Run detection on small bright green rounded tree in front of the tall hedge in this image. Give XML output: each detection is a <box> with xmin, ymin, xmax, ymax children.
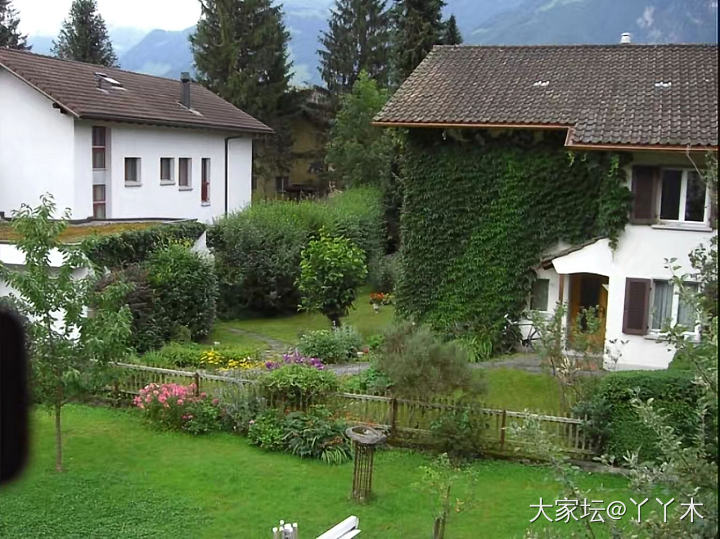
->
<box><xmin>297</xmin><ymin>232</ymin><xmax>367</xmax><ymax>327</ymax></box>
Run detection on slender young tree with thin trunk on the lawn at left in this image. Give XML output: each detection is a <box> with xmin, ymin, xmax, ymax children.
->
<box><xmin>0</xmin><ymin>195</ymin><xmax>131</xmax><ymax>471</ymax></box>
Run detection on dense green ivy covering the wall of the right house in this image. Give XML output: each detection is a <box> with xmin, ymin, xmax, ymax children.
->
<box><xmin>397</xmin><ymin>130</ymin><xmax>630</xmax><ymax>340</ymax></box>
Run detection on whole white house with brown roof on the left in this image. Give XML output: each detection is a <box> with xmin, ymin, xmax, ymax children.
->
<box><xmin>0</xmin><ymin>49</ymin><xmax>272</xmax><ymax>222</ymax></box>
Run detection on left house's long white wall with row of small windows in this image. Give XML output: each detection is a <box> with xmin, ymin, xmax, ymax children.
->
<box><xmin>105</xmin><ymin>123</ymin><xmax>252</xmax><ymax>223</ymax></box>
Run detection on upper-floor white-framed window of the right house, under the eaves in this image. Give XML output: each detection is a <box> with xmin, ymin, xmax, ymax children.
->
<box><xmin>659</xmin><ymin>169</ymin><xmax>707</xmax><ymax>223</ymax></box>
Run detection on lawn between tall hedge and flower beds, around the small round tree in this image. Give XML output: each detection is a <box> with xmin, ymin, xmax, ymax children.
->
<box><xmin>217</xmin><ymin>286</ymin><xmax>395</xmax><ymax>344</ymax></box>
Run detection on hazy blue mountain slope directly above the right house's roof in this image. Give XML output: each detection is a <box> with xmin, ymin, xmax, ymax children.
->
<box><xmin>465</xmin><ymin>0</ymin><xmax>718</xmax><ymax>45</ymax></box>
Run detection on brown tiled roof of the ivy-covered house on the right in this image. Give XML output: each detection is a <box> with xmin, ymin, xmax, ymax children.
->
<box><xmin>375</xmin><ymin>45</ymin><xmax>718</xmax><ymax>147</ymax></box>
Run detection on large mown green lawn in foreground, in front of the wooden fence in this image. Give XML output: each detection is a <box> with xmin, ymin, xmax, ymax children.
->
<box><xmin>0</xmin><ymin>405</ymin><xmax>629</xmax><ymax>539</ymax></box>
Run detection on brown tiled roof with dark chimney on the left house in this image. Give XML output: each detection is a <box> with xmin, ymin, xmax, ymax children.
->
<box><xmin>0</xmin><ymin>48</ymin><xmax>272</xmax><ymax>133</ymax></box>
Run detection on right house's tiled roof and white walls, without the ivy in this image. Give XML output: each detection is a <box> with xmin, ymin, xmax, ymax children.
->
<box><xmin>374</xmin><ymin>44</ymin><xmax>718</xmax><ymax>369</ymax></box>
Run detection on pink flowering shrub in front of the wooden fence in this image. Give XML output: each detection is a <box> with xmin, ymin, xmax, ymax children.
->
<box><xmin>133</xmin><ymin>383</ymin><xmax>220</xmax><ymax>434</ymax></box>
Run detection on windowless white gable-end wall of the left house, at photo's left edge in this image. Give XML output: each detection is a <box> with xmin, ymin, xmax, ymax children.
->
<box><xmin>0</xmin><ymin>68</ymin><xmax>76</xmax><ymax>218</ymax></box>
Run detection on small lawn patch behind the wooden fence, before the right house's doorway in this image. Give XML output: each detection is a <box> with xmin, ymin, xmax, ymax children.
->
<box><xmin>483</xmin><ymin>369</ymin><xmax>565</xmax><ymax>414</ymax></box>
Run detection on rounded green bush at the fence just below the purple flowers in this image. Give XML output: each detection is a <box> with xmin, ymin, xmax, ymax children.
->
<box><xmin>258</xmin><ymin>365</ymin><xmax>338</xmax><ymax>410</ymax></box>
